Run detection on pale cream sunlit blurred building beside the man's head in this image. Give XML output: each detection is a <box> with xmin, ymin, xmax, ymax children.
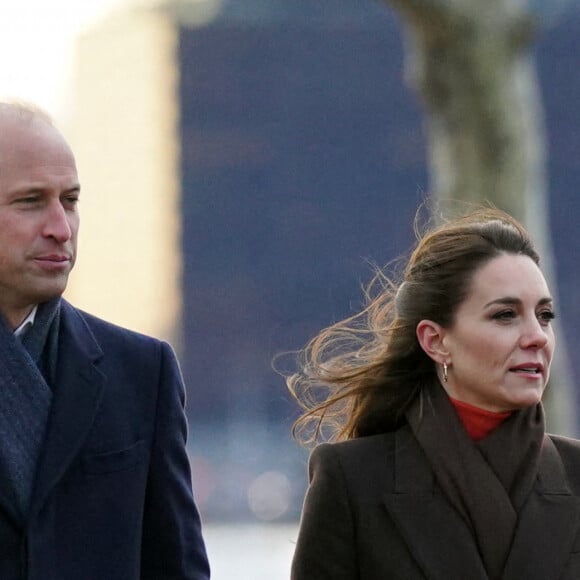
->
<box><xmin>67</xmin><ymin>0</ymin><xmax>181</xmax><ymax>343</ymax></box>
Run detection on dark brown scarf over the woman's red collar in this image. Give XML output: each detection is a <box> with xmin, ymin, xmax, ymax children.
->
<box><xmin>407</xmin><ymin>385</ymin><xmax>544</xmax><ymax>580</ymax></box>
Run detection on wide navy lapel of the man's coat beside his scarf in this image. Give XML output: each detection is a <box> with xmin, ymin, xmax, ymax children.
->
<box><xmin>31</xmin><ymin>301</ymin><xmax>105</xmax><ymax>515</ymax></box>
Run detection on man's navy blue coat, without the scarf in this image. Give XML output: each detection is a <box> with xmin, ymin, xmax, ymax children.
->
<box><xmin>0</xmin><ymin>301</ymin><xmax>209</xmax><ymax>580</ymax></box>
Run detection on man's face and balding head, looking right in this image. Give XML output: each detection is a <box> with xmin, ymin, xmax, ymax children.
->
<box><xmin>0</xmin><ymin>116</ymin><xmax>79</xmax><ymax>326</ymax></box>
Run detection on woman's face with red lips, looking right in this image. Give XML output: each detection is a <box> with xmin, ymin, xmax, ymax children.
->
<box><xmin>442</xmin><ymin>254</ymin><xmax>555</xmax><ymax>411</ymax></box>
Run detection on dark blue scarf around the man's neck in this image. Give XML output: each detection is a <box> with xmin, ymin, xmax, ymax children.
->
<box><xmin>0</xmin><ymin>298</ymin><xmax>60</xmax><ymax>518</ymax></box>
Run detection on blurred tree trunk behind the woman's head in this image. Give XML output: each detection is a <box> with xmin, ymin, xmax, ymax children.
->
<box><xmin>385</xmin><ymin>0</ymin><xmax>576</xmax><ymax>435</ymax></box>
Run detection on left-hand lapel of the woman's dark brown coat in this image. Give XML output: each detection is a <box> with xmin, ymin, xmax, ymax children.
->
<box><xmin>384</xmin><ymin>429</ymin><xmax>490</xmax><ymax>580</ymax></box>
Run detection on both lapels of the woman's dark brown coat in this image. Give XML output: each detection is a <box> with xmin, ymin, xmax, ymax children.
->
<box><xmin>384</xmin><ymin>428</ymin><xmax>580</xmax><ymax>580</ymax></box>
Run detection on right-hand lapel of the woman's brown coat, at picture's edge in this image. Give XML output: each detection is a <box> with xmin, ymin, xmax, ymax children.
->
<box><xmin>504</xmin><ymin>436</ymin><xmax>580</xmax><ymax>580</ymax></box>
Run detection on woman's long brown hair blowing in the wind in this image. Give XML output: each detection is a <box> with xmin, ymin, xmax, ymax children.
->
<box><xmin>287</xmin><ymin>208</ymin><xmax>539</xmax><ymax>444</ymax></box>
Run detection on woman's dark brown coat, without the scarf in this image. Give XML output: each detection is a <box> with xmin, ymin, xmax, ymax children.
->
<box><xmin>292</xmin><ymin>427</ymin><xmax>580</xmax><ymax>580</ymax></box>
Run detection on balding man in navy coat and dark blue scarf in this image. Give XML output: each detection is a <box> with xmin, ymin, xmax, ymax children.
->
<box><xmin>0</xmin><ymin>103</ymin><xmax>209</xmax><ymax>580</ymax></box>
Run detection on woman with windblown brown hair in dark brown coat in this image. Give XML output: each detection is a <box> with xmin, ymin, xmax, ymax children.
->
<box><xmin>288</xmin><ymin>210</ymin><xmax>580</xmax><ymax>580</ymax></box>
